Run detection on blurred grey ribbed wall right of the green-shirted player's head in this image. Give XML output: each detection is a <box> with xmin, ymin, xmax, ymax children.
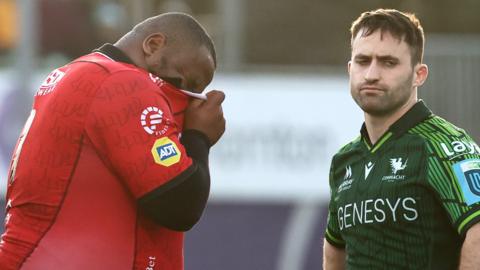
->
<box><xmin>420</xmin><ymin>34</ymin><xmax>480</xmax><ymax>143</ymax></box>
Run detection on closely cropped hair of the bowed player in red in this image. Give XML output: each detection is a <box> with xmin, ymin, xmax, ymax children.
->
<box><xmin>133</xmin><ymin>12</ymin><xmax>217</xmax><ymax>66</ymax></box>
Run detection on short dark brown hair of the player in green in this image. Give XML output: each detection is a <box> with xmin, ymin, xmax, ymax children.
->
<box><xmin>350</xmin><ymin>9</ymin><xmax>425</xmax><ymax>65</ymax></box>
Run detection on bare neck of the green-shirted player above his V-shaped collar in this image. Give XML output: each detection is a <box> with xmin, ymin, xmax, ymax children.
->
<box><xmin>364</xmin><ymin>99</ymin><xmax>417</xmax><ymax>145</ymax></box>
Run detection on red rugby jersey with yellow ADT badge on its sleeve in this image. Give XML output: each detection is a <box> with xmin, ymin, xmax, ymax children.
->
<box><xmin>0</xmin><ymin>49</ymin><xmax>197</xmax><ymax>270</ymax></box>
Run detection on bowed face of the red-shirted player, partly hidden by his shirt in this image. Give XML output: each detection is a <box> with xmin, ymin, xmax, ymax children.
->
<box><xmin>148</xmin><ymin>47</ymin><xmax>215</xmax><ymax>93</ymax></box>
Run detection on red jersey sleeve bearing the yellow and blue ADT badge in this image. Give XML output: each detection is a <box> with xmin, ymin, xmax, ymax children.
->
<box><xmin>86</xmin><ymin>71</ymin><xmax>192</xmax><ymax>199</ymax></box>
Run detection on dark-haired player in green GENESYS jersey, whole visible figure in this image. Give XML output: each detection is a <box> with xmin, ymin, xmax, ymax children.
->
<box><xmin>324</xmin><ymin>9</ymin><xmax>480</xmax><ymax>270</ymax></box>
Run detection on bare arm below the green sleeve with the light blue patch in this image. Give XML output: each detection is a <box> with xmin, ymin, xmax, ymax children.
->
<box><xmin>459</xmin><ymin>223</ymin><xmax>480</xmax><ymax>270</ymax></box>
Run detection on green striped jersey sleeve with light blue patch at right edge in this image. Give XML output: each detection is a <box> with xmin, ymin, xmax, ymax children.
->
<box><xmin>427</xmin><ymin>134</ymin><xmax>480</xmax><ymax>236</ymax></box>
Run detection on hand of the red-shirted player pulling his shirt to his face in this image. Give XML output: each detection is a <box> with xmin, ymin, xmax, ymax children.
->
<box><xmin>183</xmin><ymin>90</ymin><xmax>225</xmax><ymax>145</ymax></box>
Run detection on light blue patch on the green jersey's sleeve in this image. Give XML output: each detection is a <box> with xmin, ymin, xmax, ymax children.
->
<box><xmin>453</xmin><ymin>159</ymin><xmax>480</xmax><ymax>205</ymax></box>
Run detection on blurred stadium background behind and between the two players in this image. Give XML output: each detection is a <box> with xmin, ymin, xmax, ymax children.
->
<box><xmin>0</xmin><ymin>0</ymin><xmax>480</xmax><ymax>270</ymax></box>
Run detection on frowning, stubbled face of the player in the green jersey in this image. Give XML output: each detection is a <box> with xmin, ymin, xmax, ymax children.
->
<box><xmin>348</xmin><ymin>31</ymin><xmax>417</xmax><ymax>116</ymax></box>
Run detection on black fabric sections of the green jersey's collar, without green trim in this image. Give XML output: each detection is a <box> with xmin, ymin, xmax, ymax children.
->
<box><xmin>360</xmin><ymin>100</ymin><xmax>432</xmax><ymax>142</ymax></box>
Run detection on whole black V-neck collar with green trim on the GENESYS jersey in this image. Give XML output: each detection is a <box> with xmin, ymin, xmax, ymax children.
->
<box><xmin>360</xmin><ymin>100</ymin><xmax>432</xmax><ymax>153</ymax></box>
